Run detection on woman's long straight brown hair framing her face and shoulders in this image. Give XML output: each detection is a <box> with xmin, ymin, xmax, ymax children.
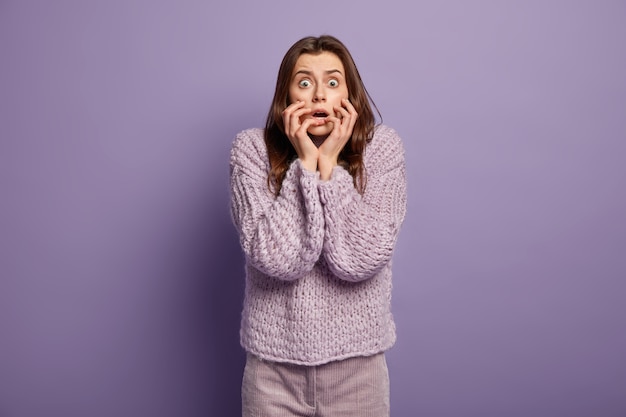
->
<box><xmin>265</xmin><ymin>35</ymin><xmax>380</xmax><ymax>195</ymax></box>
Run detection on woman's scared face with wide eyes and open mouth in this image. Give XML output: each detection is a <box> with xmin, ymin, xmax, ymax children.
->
<box><xmin>289</xmin><ymin>52</ymin><xmax>348</xmax><ymax>137</ymax></box>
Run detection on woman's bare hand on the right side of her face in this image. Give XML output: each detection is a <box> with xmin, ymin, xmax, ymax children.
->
<box><xmin>317</xmin><ymin>99</ymin><xmax>359</xmax><ymax>180</ymax></box>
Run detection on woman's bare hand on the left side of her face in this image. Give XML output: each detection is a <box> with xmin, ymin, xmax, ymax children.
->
<box><xmin>283</xmin><ymin>101</ymin><xmax>319</xmax><ymax>172</ymax></box>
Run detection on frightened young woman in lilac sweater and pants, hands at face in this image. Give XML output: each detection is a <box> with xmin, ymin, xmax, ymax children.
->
<box><xmin>230</xmin><ymin>36</ymin><xmax>406</xmax><ymax>417</ymax></box>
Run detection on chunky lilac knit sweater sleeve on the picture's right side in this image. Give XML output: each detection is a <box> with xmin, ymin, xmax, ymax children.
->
<box><xmin>319</xmin><ymin>126</ymin><xmax>406</xmax><ymax>281</ymax></box>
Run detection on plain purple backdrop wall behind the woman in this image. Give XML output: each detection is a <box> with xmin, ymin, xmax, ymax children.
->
<box><xmin>0</xmin><ymin>0</ymin><xmax>626</xmax><ymax>417</ymax></box>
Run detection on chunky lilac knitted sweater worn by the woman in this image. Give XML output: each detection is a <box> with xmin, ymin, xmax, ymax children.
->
<box><xmin>230</xmin><ymin>125</ymin><xmax>406</xmax><ymax>365</ymax></box>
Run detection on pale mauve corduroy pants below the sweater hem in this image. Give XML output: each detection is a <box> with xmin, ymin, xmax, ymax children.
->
<box><xmin>241</xmin><ymin>353</ymin><xmax>389</xmax><ymax>417</ymax></box>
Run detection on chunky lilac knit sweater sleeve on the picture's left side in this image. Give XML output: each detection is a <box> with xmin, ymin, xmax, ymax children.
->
<box><xmin>230</xmin><ymin>129</ymin><xmax>324</xmax><ymax>280</ymax></box>
